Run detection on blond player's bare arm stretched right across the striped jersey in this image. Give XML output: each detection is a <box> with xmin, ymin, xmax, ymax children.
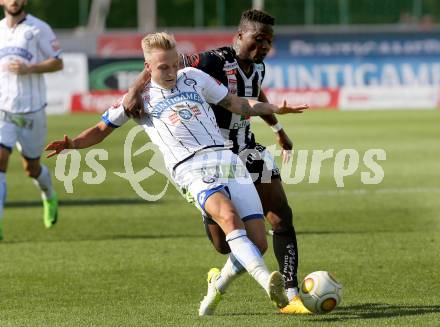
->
<box><xmin>218</xmin><ymin>93</ymin><xmax>309</xmax><ymax>116</ymax></box>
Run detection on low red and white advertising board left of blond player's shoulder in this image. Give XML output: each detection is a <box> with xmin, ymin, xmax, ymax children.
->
<box><xmin>70</xmin><ymin>90</ymin><xmax>125</xmax><ymax>113</ymax></box>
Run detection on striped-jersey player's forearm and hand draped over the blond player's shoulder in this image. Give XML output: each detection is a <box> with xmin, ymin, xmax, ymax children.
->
<box><xmin>122</xmin><ymin>69</ymin><xmax>150</xmax><ymax>118</ymax></box>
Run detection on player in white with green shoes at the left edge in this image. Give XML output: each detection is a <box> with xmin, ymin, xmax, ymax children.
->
<box><xmin>0</xmin><ymin>0</ymin><xmax>63</xmax><ymax>239</ymax></box>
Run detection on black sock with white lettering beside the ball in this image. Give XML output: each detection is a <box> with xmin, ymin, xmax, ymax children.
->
<box><xmin>273</xmin><ymin>226</ymin><xmax>298</xmax><ymax>288</ymax></box>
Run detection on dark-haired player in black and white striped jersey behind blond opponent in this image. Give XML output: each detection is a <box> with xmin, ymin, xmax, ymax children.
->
<box><xmin>124</xmin><ymin>10</ymin><xmax>309</xmax><ymax>314</ymax></box>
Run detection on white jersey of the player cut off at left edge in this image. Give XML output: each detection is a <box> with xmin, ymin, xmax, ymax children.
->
<box><xmin>0</xmin><ymin>14</ymin><xmax>61</xmax><ymax>113</ymax></box>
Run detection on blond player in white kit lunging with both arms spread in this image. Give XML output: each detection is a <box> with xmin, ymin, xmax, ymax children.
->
<box><xmin>46</xmin><ymin>33</ymin><xmax>306</xmax><ymax>315</ymax></box>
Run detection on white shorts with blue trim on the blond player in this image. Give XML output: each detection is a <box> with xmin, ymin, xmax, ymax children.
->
<box><xmin>173</xmin><ymin>149</ymin><xmax>264</xmax><ymax>221</ymax></box>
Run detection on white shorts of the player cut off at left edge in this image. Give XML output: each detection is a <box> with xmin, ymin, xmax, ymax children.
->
<box><xmin>0</xmin><ymin>109</ymin><xmax>47</xmax><ymax>159</ymax></box>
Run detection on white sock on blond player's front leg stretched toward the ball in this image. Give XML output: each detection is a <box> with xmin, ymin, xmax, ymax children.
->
<box><xmin>226</xmin><ymin>229</ymin><xmax>270</xmax><ymax>292</ymax></box>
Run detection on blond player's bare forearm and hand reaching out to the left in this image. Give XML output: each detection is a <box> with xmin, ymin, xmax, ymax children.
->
<box><xmin>45</xmin><ymin>121</ymin><xmax>115</xmax><ymax>158</ymax></box>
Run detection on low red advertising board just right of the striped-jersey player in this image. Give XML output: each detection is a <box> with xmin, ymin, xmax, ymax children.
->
<box><xmin>264</xmin><ymin>88</ymin><xmax>339</xmax><ymax>109</ymax></box>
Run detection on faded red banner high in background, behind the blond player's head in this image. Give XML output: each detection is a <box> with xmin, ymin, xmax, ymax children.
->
<box><xmin>97</xmin><ymin>32</ymin><xmax>234</xmax><ymax>57</ymax></box>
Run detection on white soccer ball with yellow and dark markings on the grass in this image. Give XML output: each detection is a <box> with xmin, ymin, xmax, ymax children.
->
<box><xmin>299</xmin><ymin>271</ymin><xmax>342</xmax><ymax>313</ymax></box>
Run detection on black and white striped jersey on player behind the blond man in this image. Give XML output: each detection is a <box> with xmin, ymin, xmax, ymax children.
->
<box><xmin>182</xmin><ymin>47</ymin><xmax>265</xmax><ymax>153</ymax></box>
